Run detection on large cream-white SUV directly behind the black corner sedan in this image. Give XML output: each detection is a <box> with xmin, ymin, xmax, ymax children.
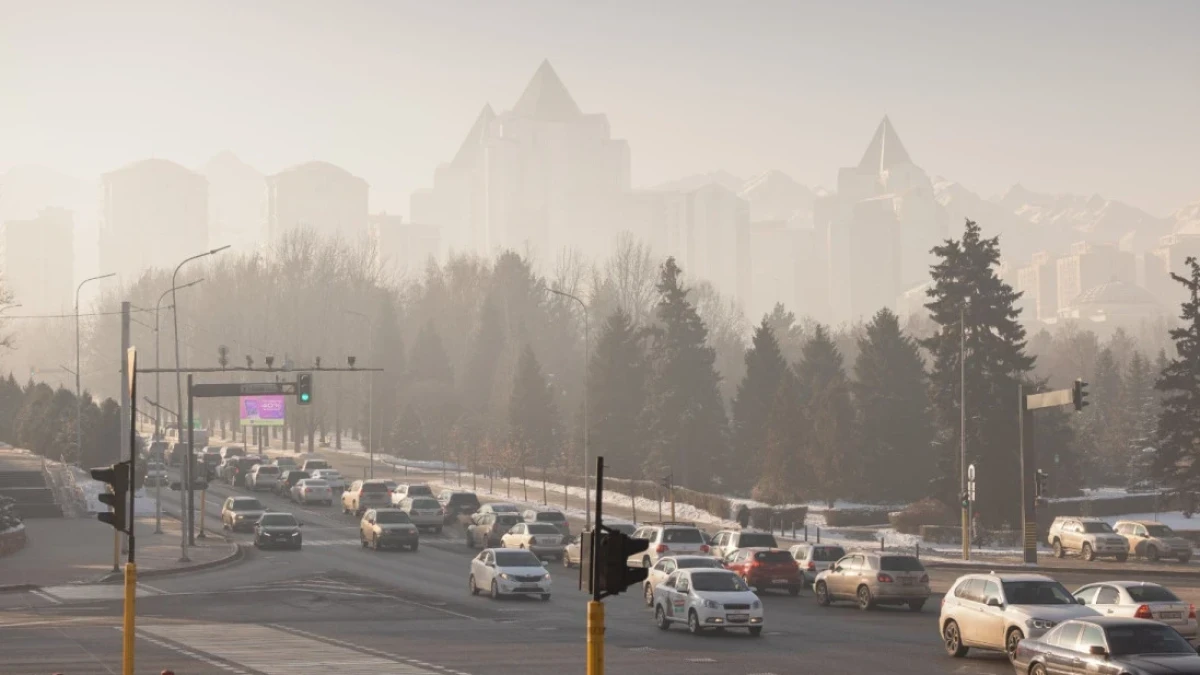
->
<box><xmin>940</xmin><ymin>573</ymin><xmax>1098</xmax><ymax>661</ymax></box>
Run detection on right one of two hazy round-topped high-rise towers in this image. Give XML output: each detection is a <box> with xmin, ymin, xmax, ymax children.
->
<box><xmin>266</xmin><ymin>162</ymin><xmax>370</xmax><ymax>244</ymax></box>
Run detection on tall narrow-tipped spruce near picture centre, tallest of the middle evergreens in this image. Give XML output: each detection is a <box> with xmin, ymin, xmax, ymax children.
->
<box><xmin>643</xmin><ymin>257</ymin><xmax>728</xmax><ymax>490</ymax></box>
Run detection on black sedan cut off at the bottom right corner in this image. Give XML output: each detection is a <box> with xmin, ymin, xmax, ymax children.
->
<box><xmin>1013</xmin><ymin>616</ymin><xmax>1200</xmax><ymax>675</ymax></box>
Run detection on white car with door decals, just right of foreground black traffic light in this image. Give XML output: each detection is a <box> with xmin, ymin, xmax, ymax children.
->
<box><xmin>654</xmin><ymin>569</ymin><xmax>763</xmax><ymax>637</ymax></box>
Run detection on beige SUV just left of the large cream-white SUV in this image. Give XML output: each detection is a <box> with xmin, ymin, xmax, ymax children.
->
<box><xmin>812</xmin><ymin>552</ymin><xmax>930</xmax><ymax>611</ymax></box>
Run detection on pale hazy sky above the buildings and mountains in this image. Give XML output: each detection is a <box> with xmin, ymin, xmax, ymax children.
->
<box><xmin>0</xmin><ymin>0</ymin><xmax>1200</xmax><ymax>214</ymax></box>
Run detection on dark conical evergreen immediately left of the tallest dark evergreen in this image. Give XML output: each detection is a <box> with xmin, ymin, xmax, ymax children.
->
<box><xmin>853</xmin><ymin>309</ymin><xmax>936</xmax><ymax>503</ymax></box>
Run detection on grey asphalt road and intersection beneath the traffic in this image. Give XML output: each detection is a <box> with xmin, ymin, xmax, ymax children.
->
<box><xmin>7</xmin><ymin>461</ymin><xmax>1200</xmax><ymax>675</ymax></box>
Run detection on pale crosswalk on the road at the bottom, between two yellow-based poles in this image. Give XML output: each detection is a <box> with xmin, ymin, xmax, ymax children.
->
<box><xmin>138</xmin><ymin>623</ymin><xmax>455</xmax><ymax>675</ymax></box>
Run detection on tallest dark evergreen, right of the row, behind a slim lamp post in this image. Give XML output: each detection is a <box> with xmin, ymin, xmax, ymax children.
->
<box><xmin>922</xmin><ymin>220</ymin><xmax>1034</xmax><ymax>525</ymax></box>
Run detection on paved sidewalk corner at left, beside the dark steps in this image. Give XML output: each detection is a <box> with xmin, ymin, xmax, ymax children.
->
<box><xmin>0</xmin><ymin>515</ymin><xmax>240</xmax><ymax>590</ymax></box>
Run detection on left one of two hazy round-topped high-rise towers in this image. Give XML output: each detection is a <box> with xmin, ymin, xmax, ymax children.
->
<box><xmin>100</xmin><ymin>160</ymin><xmax>209</xmax><ymax>281</ymax></box>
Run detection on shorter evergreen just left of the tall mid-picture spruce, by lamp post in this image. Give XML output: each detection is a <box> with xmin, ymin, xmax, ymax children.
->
<box><xmin>588</xmin><ymin>307</ymin><xmax>646</xmax><ymax>478</ymax></box>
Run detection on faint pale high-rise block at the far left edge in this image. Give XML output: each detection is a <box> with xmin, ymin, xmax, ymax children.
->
<box><xmin>4</xmin><ymin>209</ymin><xmax>74</xmax><ymax>313</ymax></box>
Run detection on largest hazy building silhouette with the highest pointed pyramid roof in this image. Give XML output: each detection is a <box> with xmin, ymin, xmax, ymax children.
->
<box><xmin>410</xmin><ymin>61</ymin><xmax>630</xmax><ymax>259</ymax></box>
